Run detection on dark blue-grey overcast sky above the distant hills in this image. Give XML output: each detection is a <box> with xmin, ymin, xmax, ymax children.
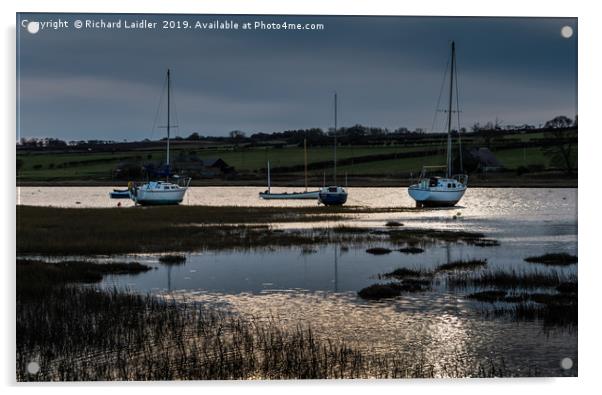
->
<box><xmin>17</xmin><ymin>14</ymin><xmax>577</xmax><ymax>141</ymax></box>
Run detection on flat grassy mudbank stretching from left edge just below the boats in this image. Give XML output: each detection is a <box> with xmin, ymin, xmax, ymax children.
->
<box><xmin>17</xmin><ymin>206</ymin><xmax>492</xmax><ymax>255</ymax></box>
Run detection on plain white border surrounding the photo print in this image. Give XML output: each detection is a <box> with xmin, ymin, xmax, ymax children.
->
<box><xmin>0</xmin><ymin>0</ymin><xmax>602</xmax><ymax>395</ymax></box>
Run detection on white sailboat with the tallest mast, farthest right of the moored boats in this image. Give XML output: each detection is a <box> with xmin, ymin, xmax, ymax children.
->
<box><xmin>408</xmin><ymin>41</ymin><xmax>468</xmax><ymax>207</ymax></box>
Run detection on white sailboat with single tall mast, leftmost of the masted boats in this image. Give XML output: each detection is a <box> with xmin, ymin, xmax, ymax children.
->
<box><xmin>128</xmin><ymin>69</ymin><xmax>191</xmax><ymax>205</ymax></box>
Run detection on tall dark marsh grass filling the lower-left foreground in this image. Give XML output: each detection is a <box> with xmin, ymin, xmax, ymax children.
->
<box><xmin>16</xmin><ymin>261</ymin><xmax>502</xmax><ymax>381</ymax></box>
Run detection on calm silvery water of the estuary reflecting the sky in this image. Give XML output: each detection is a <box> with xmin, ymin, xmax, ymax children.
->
<box><xmin>18</xmin><ymin>187</ymin><xmax>577</xmax><ymax>376</ymax></box>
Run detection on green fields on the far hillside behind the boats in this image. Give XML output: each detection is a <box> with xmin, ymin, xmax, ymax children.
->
<box><xmin>17</xmin><ymin>132</ymin><xmax>577</xmax><ymax>182</ymax></box>
